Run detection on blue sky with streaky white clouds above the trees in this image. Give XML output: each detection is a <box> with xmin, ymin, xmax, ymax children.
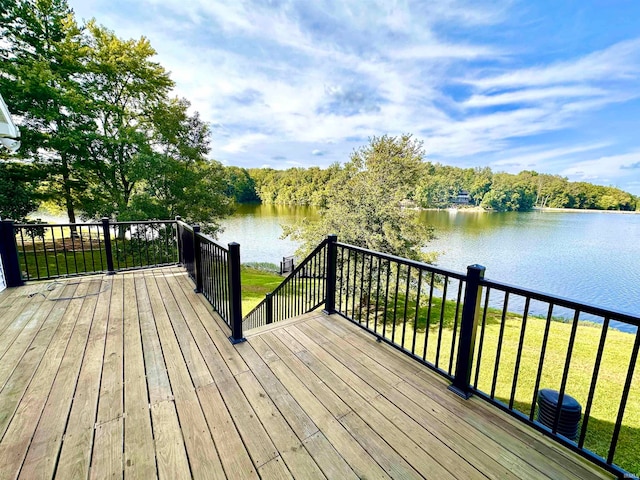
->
<box><xmin>69</xmin><ymin>0</ymin><xmax>640</xmax><ymax>195</ymax></box>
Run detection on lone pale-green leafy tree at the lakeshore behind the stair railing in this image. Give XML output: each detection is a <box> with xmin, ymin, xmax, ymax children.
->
<box><xmin>285</xmin><ymin>135</ymin><xmax>433</xmax><ymax>259</ymax></box>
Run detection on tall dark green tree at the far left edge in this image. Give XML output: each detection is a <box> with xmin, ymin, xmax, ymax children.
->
<box><xmin>0</xmin><ymin>0</ymin><xmax>95</xmax><ymax>229</ymax></box>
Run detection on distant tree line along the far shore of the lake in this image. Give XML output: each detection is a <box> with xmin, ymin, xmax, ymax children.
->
<box><xmin>242</xmin><ymin>162</ymin><xmax>640</xmax><ymax>212</ymax></box>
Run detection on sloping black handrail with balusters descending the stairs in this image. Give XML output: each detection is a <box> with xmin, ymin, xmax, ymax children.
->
<box><xmin>243</xmin><ymin>237</ymin><xmax>335</xmax><ymax>330</ymax></box>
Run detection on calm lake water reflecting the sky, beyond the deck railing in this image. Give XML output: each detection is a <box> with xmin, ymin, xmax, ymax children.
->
<box><xmin>220</xmin><ymin>205</ymin><xmax>640</xmax><ymax>324</ymax></box>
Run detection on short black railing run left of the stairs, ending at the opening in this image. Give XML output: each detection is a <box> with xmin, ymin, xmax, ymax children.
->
<box><xmin>176</xmin><ymin>217</ymin><xmax>244</xmax><ymax>343</ymax></box>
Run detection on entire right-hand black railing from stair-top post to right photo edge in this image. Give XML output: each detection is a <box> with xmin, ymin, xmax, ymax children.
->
<box><xmin>327</xmin><ymin>238</ymin><xmax>640</xmax><ymax>476</ymax></box>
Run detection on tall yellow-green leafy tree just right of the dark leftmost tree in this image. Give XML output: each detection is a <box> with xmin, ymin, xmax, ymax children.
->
<box><xmin>82</xmin><ymin>22</ymin><xmax>173</xmax><ymax>218</ymax></box>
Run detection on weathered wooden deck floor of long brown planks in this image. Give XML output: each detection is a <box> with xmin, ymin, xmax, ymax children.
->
<box><xmin>0</xmin><ymin>268</ymin><xmax>608</xmax><ymax>480</ymax></box>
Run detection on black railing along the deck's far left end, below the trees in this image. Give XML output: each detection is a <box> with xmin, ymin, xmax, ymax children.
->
<box><xmin>2</xmin><ymin>218</ymin><xmax>178</xmax><ymax>282</ymax></box>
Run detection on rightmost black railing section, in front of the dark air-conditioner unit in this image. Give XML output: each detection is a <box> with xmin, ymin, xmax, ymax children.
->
<box><xmin>471</xmin><ymin>279</ymin><xmax>640</xmax><ymax>475</ymax></box>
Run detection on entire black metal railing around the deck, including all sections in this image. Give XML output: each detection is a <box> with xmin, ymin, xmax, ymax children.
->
<box><xmin>0</xmin><ymin>219</ymin><xmax>640</xmax><ymax>476</ymax></box>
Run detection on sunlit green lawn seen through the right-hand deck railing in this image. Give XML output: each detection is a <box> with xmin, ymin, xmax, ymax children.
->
<box><xmin>355</xmin><ymin>298</ymin><xmax>640</xmax><ymax>475</ymax></box>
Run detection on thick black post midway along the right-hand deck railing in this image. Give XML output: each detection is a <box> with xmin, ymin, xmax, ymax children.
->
<box><xmin>449</xmin><ymin>265</ymin><xmax>485</xmax><ymax>399</ymax></box>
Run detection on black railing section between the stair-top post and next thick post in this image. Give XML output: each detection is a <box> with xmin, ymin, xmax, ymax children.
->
<box><xmin>335</xmin><ymin>243</ymin><xmax>465</xmax><ymax>379</ymax></box>
